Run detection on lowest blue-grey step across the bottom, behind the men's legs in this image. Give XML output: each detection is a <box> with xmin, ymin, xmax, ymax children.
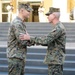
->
<box><xmin>0</xmin><ymin>65</ymin><xmax>75</xmax><ymax>75</ymax></box>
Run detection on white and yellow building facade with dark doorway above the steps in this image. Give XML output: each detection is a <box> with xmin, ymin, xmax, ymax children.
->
<box><xmin>0</xmin><ymin>0</ymin><xmax>75</xmax><ymax>22</ymax></box>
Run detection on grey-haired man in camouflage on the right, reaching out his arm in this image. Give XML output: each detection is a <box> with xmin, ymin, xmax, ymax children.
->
<box><xmin>20</xmin><ymin>7</ymin><xmax>66</xmax><ymax>75</ymax></box>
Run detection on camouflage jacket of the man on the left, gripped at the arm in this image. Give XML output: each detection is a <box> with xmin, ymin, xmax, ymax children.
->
<box><xmin>7</xmin><ymin>17</ymin><xmax>33</xmax><ymax>59</ymax></box>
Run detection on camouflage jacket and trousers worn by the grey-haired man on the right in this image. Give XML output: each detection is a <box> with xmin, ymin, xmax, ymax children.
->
<box><xmin>35</xmin><ymin>22</ymin><xmax>66</xmax><ymax>75</ymax></box>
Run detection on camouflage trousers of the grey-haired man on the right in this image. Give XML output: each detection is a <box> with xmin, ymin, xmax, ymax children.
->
<box><xmin>48</xmin><ymin>64</ymin><xmax>63</xmax><ymax>75</ymax></box>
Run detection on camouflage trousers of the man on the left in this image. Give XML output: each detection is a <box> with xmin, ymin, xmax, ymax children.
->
<box><xmin>8</xmin><ymin>58</ymin><xmax>25</xmax><ymax>75</ymax></box>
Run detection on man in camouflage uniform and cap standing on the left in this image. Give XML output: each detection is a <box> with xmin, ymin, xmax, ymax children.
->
<box><xmin>7</xmin><ymin>3</ymin><xmax>33</xmax><ymax>75</ymax></box>
